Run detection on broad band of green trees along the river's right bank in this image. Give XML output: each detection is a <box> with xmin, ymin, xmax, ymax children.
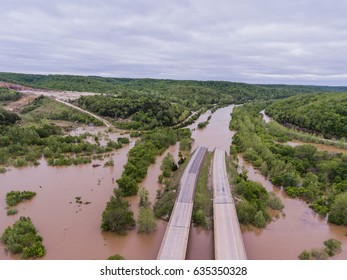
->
<box><xmin>231</xmin><ymin>102</ymin><xmax>347</xmax><ymax>225</ymax></box>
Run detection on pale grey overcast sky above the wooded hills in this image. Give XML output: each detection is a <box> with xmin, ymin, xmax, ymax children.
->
<box><xmin>0</xmin><ymin>0</ymin><xmax>347</xmax><ymax>85</ymax></box>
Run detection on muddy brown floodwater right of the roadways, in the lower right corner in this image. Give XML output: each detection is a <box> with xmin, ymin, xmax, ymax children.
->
<box><xmin>239</xmin><ymin>157</ymin><xmax>347</xmax><ymax>260</ymax></box>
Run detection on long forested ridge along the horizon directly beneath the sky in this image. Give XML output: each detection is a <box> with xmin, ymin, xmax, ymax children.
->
<box><xmin>0</xmin><ymin>73</ymin><xmax>312</xmax><ymax>104</ymax></box>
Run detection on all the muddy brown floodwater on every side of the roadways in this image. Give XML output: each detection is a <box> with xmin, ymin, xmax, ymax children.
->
<box><xmin>0</xmin><ymin>106</ymin><xmax>347</xmax><ymax>260</ymax></box>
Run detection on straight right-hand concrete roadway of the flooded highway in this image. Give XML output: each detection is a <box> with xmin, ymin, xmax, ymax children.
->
<box><xmin>213</xmin><ymin>149</ymin><xmax>247</xmax><ymax>260</ymax></box>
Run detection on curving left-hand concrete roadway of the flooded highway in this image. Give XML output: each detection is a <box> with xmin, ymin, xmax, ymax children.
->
<box><xmin>157</xmin><ymin>147</ymin><xmax>207</xmax><ymax>260</ymax></box>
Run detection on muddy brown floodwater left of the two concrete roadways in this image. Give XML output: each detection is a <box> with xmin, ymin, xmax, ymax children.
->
<box><xmin>0</xmin><ymin>128</ymin><xmax>178</xmax><ymax>260</ymax></box>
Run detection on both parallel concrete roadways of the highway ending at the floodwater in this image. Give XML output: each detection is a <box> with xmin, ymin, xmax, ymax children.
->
<box><xmin>157</xmin><ymin>147</ymin><xmax>247</xmax><ymax>260</ymax></box>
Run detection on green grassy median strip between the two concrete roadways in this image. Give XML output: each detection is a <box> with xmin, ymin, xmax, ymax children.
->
<box><xmin>193</xmin><ymin>152</ymin><xmax>213</xmax><ymax>229</ymax></box>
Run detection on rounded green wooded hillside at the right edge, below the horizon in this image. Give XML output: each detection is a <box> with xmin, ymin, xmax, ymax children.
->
<box><xmin>266</xmin><ymin>93</ymin><xmax>347</xmax><ymax>138</ymax></box>
